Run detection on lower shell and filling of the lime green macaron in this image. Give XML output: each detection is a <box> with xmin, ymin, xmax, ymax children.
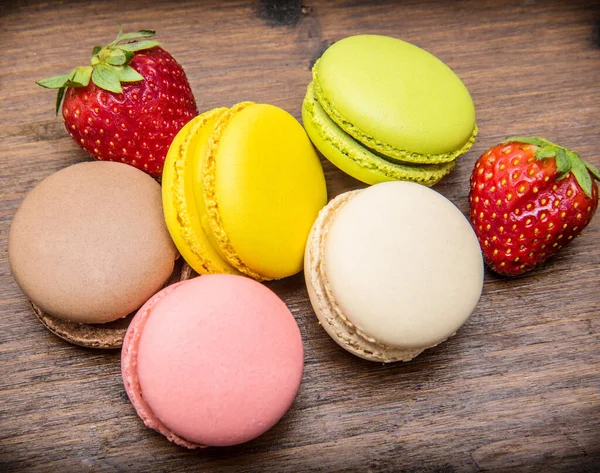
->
<box><xmin>302</xmin><ymin>82</ymin><xmax>456</xmax><ymax>186</ymax></box>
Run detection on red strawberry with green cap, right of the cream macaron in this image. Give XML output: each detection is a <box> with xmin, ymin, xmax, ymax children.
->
<box><xmin>469</xmin><ymin>137</ymin><xmax>600</xmax><ymax>276</ymax></box>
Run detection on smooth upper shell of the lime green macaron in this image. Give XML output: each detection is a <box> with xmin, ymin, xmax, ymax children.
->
<box><xmin>313</xmin><ymin>35</ymin><xmax>475</xmax><ymax>159</ymax></box>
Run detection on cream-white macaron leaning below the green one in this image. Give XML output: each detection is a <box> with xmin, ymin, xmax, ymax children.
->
<box><xmin>305</xmin><ymin>181</ymin><xmax>483</xmax><ymax>362</ymax></box>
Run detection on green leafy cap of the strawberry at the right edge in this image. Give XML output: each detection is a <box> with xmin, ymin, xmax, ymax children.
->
<box><xmin>502</xmin><ymin>136</ymin><xmax>600</xmax><ymax>197</ymax></box>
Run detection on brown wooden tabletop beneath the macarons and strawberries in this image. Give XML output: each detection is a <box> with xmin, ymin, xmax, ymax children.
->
<box><xmin>0</xmin><ymin>0</ymin><xmax>600</xmax><ymax>472</ymax></box>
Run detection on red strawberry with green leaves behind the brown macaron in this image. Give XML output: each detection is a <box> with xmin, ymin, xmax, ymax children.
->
<box><xmin>37</xmin><ymin>30</ymin><xmax>198</xmax><ymax>177</ymax></box>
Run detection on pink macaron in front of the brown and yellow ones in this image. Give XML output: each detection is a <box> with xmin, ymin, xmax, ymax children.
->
<box><xmin>121</xmin><ymin>274</ymin><xmax>304</xmax><ymax>448</ymax></box>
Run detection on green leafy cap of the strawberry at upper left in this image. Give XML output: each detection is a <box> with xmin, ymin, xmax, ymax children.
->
<box><xmin>36</xmin><ymin>26</ymin><xmax>159</xmax><ymax>115</ymax></box>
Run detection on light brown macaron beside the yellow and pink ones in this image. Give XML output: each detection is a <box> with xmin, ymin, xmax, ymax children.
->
<box><xmin>8</xmin><ymin>162</ymin><xmax>178</xmax><ymax>348</ymax></box>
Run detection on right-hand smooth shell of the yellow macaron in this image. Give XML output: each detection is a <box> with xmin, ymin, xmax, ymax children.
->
<box><xmin>204</xmin><ymin>102</ymin><xmax>327</xmax><ymax>279</ymax></box>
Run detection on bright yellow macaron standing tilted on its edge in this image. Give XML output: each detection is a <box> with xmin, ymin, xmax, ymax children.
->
<box><xmin>162</xmin><ymin>102</ymin><xmax>327</xmax><ymax>281</ymax></box>
